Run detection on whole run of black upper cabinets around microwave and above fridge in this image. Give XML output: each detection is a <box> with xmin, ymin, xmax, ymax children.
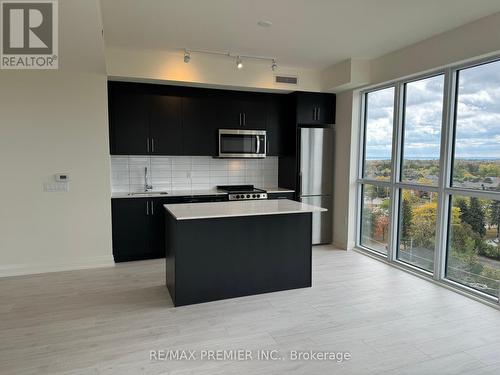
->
<box><xmin>108</xmin><ymin>82</ymin><xmax>335</xmax><ymax>156</ymax></box>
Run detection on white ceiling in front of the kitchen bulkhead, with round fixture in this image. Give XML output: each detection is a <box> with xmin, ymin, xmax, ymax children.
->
<box><xmin>101</xmin><ymin>0</ymin><xmax>500</xmax><ymax>69</ymax></box>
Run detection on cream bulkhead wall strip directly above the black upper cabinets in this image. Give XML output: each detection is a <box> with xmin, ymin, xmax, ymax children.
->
<box><xmin>106</xmin><ymin>47</ymin><xmax>321</xmax><ymax>91</ymax></box>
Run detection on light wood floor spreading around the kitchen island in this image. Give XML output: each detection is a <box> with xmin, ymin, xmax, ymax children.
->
<box><xmin>0</xmin><ymin>247</ymin><xmax>500</xmax><ymax>375</ymax></box>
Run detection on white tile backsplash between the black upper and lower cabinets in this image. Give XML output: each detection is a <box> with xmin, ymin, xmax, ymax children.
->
<box><xmin>111</xmin><ymin>156</ymin><xmax>278</xmax><ymax>192</ymax></box>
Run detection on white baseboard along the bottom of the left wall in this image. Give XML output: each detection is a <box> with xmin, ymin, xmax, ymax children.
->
<box><xmin>0</xmin><ymin>255</ymin><xmax>115</xmax><ymax>277</ymax></box>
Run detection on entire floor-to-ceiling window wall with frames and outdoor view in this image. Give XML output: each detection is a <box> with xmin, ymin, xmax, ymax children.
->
<box><xmin>357</xmin><ymin>61</ymin><xmax>500</xmax><ymax>306</ymax></box>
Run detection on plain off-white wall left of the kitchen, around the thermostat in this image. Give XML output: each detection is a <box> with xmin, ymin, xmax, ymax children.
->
<box><xmin>0</xmin><ymin>71</ymin><xmax>113</xmax><ymax>276</ymax></box>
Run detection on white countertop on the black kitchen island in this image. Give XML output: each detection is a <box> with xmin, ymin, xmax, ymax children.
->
<box><xmin>164</xmin><ymin>199</ymin><xmax>327</xmax><ymax>220</ymax></box>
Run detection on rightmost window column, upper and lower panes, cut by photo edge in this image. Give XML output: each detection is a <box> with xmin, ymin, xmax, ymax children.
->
<box><xmin>446</xmin><ymin>61</ymin><xmax>500</xmax><ymax>297</ymax></box>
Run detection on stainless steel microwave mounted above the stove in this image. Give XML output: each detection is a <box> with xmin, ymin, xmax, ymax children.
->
<box><xmin>219</xmin><ymin>129</ymin><xmax>267</xmax><ymax>158</ymax></box>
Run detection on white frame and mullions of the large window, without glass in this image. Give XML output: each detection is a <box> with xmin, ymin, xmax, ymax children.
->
<box><xmin>355</xmin><ymin>56</ymin><xmax>500</xmax><ymax>307</ymax></box>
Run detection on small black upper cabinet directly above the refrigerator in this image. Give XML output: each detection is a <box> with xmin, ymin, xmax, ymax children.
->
<box><xmin>294</xmin><ymin>92</ymin><xmax>335</xmax><ymax>125</ymax></box>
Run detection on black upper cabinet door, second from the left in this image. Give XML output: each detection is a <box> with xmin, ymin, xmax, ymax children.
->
<box><xmin>150</xmin><ymin>95</ymin><xmax>186</xmax><ymax>155</ymax></box>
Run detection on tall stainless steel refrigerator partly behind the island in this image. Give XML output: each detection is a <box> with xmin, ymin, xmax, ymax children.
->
<box><xmin>299</xmin><ymin>128</ymin><xmax>335</xmax><ymax>245</ymax></box>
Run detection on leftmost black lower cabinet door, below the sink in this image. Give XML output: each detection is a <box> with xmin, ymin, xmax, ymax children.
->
<box><xmin>111</xmin><ymin>198</ymin><xmax>151</xmax><ymax>262</ymax></box>
